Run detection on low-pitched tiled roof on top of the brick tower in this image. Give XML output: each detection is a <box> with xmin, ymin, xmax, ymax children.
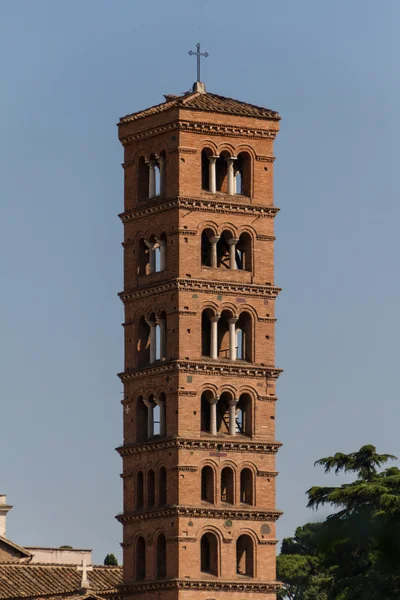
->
<box><xmin>120</xmin><ymin>92</ymin><xmax>280</xmax><ymax>124</ymax></box>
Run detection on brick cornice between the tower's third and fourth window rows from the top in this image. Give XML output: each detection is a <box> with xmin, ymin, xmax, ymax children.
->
<box><xmin>118</xmin><ymin>359</ymin><xmax>283</xmax><ymax>383</ymax></box>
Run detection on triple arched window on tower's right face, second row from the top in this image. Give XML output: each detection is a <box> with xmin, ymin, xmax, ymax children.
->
<box><xmin>201</xmin><ymin>228</ymin><xmax>253</xmax><ymax>271</ymax></box>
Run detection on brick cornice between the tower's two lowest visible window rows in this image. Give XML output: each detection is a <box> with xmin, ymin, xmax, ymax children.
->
<box><xmin>116</xmin><ymin>506</ymin><xmax>283</xmax><ymax>523</ymax></box>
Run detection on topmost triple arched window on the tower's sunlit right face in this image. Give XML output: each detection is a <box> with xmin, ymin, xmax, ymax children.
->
<box><xmin>201</xmin><ymin>148</ymin><xmax>252</xmax><ymax>197</ymax></box>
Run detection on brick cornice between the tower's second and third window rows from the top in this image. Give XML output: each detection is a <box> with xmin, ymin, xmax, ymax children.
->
<box><xmin>118</xmin><ymin>277</ymin><xmax>281</xmax><ymax>304</ymax></box>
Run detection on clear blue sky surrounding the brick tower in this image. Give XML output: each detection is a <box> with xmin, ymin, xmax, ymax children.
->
<box><xmin>0</xmin><ymin>0</ymin><xmax>400</xmax><ymax>562</ymax></box>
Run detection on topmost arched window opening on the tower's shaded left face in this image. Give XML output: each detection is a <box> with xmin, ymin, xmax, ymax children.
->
<box><xmin>137</xmin><ymin>151</ymin><xmax>166</xmax><ymax>201</ymax></box>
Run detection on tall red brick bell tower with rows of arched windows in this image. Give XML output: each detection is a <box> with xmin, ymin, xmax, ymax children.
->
<box><xmin>118</xmin><ymin>83</ymin><xmax>280</xmax><ymax>600</ymax></box>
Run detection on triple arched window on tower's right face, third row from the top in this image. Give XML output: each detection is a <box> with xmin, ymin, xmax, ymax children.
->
<box><xmin>201</xmin><ymin>308</ymin><xmax>253</xmax><ymax>362</ymax></box>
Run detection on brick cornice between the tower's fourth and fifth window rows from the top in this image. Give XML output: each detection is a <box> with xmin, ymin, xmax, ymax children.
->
<box><xmin>116</xmin><ymin>438</ymin><xmax>282</xmax><ymax>457</ymax></box>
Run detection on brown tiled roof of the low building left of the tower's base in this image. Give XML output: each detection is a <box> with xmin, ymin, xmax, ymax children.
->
<box><xmin>0</xmin><ymin>563</ymin><xmax>122</xmax><ymax>599</ymax></box>
